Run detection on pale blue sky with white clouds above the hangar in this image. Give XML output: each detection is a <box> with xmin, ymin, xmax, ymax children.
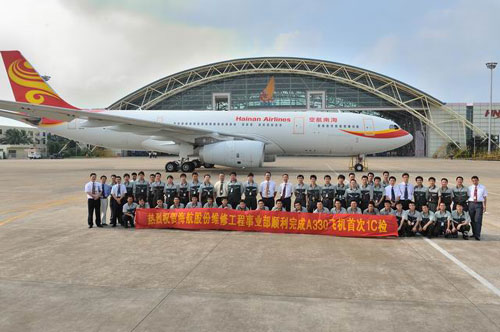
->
<box><xmin>0</xmin><ymin>0</ymin><xmax>500</xmax><ymax>124</ymax></box>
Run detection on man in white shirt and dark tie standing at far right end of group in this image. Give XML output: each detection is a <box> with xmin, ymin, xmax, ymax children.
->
<box><xmin>468</xmin><ymin>175</ymin><xmax>488</xmax><ymax>241</ymax></box>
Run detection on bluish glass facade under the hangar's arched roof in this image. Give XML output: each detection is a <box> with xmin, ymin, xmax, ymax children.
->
<box><xmin>150</xmin><ymin>73</ymin><xmax>396</xmax><ymax>110</ymax></box>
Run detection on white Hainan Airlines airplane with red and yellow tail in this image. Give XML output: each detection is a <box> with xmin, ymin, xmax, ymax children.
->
<box><xmin>0</xmin><ymin>51</ymin><xmax>413</xmax><ymax>172</ymax></box>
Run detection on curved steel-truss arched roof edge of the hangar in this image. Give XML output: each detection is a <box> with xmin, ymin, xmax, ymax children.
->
<box><xmin>108</xmin><ymin>57</ymin><xmax>443</xmax><ymax>109</ymax></box>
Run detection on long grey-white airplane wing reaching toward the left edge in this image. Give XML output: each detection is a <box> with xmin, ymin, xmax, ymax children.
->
<box><xmin>0</xmin><ymin>100</ymin><xmax>267</xmax><ymax>144</ymax></box>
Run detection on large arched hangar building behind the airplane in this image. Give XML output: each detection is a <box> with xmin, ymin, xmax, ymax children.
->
<box><xmin>108</xmin><ymin>57</ymin><xmax>500</xmax><ymax>157</ymax></box>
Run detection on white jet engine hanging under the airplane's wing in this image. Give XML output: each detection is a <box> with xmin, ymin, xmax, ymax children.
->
<box><xmin>198</xmin><ymin>140</ymin><xmax>264</xmax><ymax>168</ymax></box>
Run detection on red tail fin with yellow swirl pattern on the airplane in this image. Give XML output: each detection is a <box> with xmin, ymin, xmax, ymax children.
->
<box><xmin>0</xmin><ymin>51</ymin><xmax>77</xmax><ymax>109</ymax></box>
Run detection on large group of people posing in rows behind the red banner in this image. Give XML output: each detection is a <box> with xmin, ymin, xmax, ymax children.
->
<box><xmin>85</xmin><ymin>171</ymin><xmax>488</xmax><ymax>240</ymax></box>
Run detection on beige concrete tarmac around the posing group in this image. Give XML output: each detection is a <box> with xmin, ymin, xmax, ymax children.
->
<box><xmin>0</xmin><ymin>157</ymin><xmax>500</xmax><ymax>332</ymax></box>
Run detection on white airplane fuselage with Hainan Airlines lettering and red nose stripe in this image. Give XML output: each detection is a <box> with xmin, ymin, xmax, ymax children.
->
<box><xmin>43</xmin><ymin>110</ymin><xmax>413</xmax><ymax>156</ymax></box>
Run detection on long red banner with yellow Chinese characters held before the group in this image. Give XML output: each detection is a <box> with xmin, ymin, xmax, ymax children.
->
<box><xmin>135</xmin><ymin>208</ymin><xmax>398</xmax><ymax>237</ymax></box>
